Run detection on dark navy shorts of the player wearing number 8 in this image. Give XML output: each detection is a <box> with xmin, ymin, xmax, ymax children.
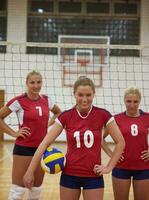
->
<box><xmin>112</xmin><ymin>168</ymin><xmax>149</xmax><ymax>180</ymax></box>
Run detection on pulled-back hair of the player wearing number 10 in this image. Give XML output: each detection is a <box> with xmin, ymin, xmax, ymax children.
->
<box><xmin>73</xmin><ymin>76</ymin><xmax>95</xmax><ymax>93</ymax></box>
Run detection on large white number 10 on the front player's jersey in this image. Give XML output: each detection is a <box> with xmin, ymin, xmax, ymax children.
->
<box><xmin>74</xmin><ymin>130</ymin><xmax>94</xmax><ymax>148</ymax></box>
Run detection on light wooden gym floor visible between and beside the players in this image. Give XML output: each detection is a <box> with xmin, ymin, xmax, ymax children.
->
<box><xmin>0</xmin><ymin>142</ymin><xmax>133</xmax><ymax>200</ymax></box>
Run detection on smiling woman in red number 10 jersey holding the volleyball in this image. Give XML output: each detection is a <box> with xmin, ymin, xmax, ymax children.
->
<box><xmin>24</xmin><ymin>76</ymin><xmax>125</xmax><ymax>200</ymax></box>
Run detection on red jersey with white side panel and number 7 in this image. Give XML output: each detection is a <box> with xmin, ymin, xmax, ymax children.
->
<box><xmin>6</xmin><ymin>94</ymin><xmax>54</xmax><ymax>147</ymax></box>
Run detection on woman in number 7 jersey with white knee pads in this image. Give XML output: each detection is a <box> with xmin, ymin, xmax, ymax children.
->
<box><xmin>0</xmin><ymin>71</ymin><xmax>60</xmax><ymax>200</ymax></box>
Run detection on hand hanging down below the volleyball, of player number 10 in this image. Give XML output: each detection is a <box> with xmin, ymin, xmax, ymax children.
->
<box><xmin>23</xmin><ymin>172</ymin><xmax>34</xmax><ymax>189</ymax></box>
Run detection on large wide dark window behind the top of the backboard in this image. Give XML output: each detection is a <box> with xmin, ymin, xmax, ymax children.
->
<box><xmin>27</xmin><ymin>0</ymin><xmax>140</xmax><ymax>55</ymax></box>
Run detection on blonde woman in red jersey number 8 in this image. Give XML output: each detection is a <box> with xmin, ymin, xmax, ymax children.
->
<box><xmin>100</xmin><ymin>87</ymin><xmax>149</xmax><ymax>200</ymax></box>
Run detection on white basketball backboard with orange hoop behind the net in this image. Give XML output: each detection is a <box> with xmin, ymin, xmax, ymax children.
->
<box><xmin>58</xmin><ymin>35</ymin><xmax>110</xmax><ymax>86</ymax></box>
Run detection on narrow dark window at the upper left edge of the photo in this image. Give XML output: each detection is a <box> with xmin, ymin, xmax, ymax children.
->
<box><xmin>0</xmin><ymin>0</ymin><xmax>7</xmax><ymax>53</ymax></box>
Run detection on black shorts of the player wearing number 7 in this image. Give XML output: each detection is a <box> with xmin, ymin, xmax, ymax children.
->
<box><xmin>13</xmin><ymin>144</ymin><xmax>37</xmax><ymax>156</ymax></box>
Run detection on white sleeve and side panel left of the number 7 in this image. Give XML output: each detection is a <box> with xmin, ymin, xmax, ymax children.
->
<box><xmin>9</xmin><ymin>100</ymin><xmax>24</xmax><ymax>125</ymax></box>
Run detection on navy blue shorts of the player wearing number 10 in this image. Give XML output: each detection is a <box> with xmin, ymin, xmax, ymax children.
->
<box><xmin>60</xmin><ymin>173</ymin><xmax>104</xmax><ymax>189</ymax></box>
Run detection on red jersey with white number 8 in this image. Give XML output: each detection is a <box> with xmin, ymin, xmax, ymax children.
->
<box><xmin>115</xmin><ymin>110</ymin><xmax>149</xmax><ymax>170</ymax></box>
